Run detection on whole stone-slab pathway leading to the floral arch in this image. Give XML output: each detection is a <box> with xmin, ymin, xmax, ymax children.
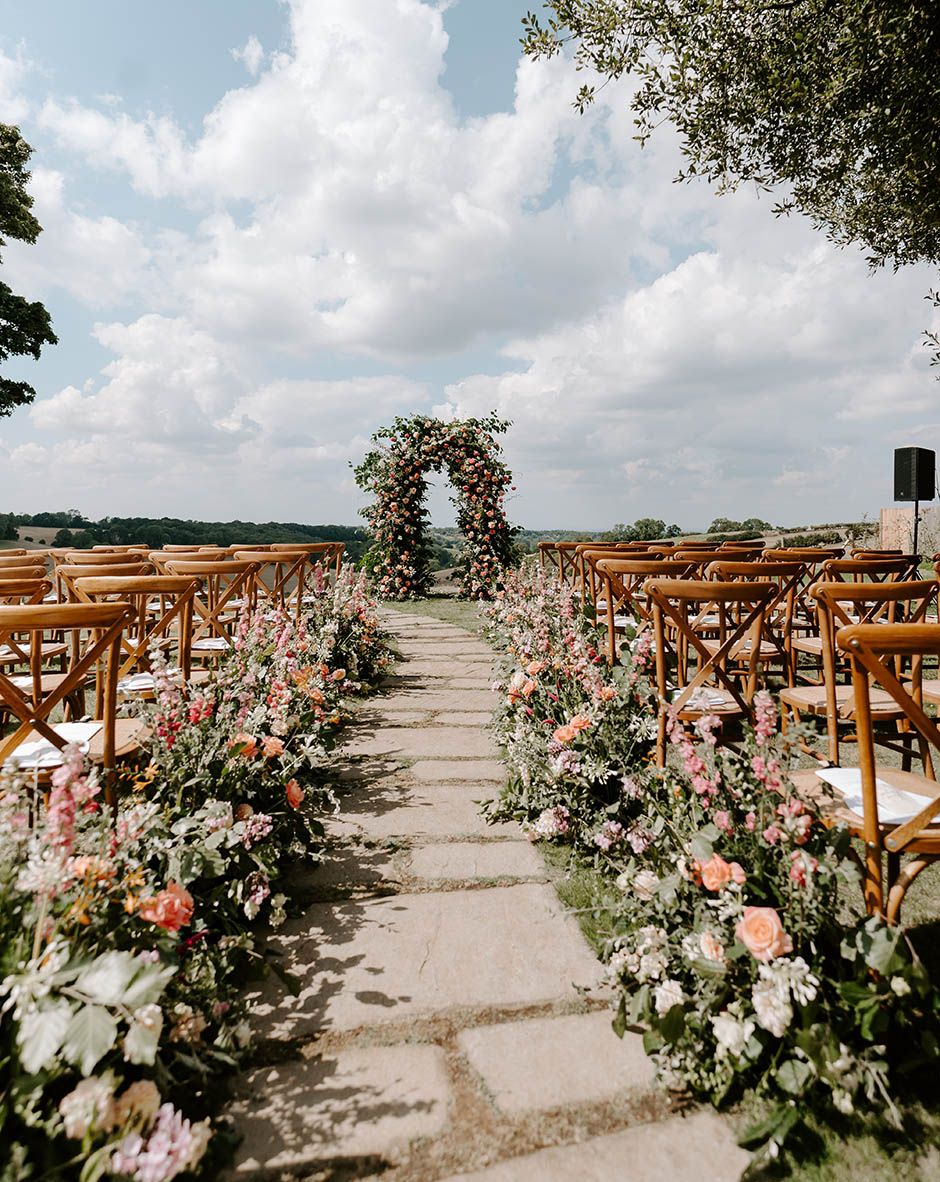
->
<box><xmin>229</xmin><ymin>612</ymin><xmax>747</xmax><ymax>1182</ymax></box>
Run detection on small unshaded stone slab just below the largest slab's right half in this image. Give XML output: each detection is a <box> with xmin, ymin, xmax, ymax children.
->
<box><xmin>458</xmin><ymin>1011</ymin><xmax>654</xmax><ymax>1116</ymax></box>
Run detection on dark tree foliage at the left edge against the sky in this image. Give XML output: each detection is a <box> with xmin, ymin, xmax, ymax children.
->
<box><xmin>0</xmin><ymin>123</ymin><xmax>57</xmax><ymax>417</ymax></box>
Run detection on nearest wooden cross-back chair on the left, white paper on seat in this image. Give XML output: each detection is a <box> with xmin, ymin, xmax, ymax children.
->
<box><xmin>0</xmin><ymin>603</ymin><xmax>144</xmax><ymax>804</ymax></box>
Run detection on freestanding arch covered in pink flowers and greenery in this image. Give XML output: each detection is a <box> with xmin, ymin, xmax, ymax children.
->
<box><xmin>356</xmin><ymin>415</ymin><xmax>516</xmax><ymax>599</ymax></box>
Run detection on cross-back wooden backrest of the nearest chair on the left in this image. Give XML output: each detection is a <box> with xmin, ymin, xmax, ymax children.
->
<box><xmin>0</xmin><ymin>603</ymin><xmax>131</xmax><ymax>803</ymax></box>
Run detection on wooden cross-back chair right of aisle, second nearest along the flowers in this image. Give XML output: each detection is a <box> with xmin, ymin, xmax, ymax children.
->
<box><xmin>646</xmin><ymin>578</ymin><xmax>777</xmax><ymax>767</ymax></box>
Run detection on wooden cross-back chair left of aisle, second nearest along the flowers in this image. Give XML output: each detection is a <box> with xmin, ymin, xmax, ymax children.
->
<box><xmin>74</xmin><ymin>574</ymin><xmax>199</xmax><ymax>697</ymax></box>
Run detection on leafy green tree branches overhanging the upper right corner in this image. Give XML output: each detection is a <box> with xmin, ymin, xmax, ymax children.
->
<box><xmin>523</xmin><ymin>0</ymin><xmax>940</xmax><ymax>267</ymax></box>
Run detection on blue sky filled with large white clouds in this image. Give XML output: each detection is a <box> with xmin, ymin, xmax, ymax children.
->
<box><xmin>0</xmin><ymin>0</ymin><xmax>938</xmax><ymax>528</ymax></box>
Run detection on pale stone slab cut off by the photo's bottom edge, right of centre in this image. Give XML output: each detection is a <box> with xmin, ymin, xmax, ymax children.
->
<box><xmin>446</xmin><ymin>1112</ymin><xmax>750</xmax><ymax>1182</ymax></box>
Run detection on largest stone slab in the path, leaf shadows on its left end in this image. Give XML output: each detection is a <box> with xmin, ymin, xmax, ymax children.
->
<box><xmin>248</xmin><ymin>883</ymin><xmax>601</xmax><ymax>1039</ymax></box>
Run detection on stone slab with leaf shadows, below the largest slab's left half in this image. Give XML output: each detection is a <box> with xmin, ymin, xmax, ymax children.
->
<box><xmin>228</xmin><ymin>1045</ymin><xmax>449</xmax><ymax>1176</ymax></box>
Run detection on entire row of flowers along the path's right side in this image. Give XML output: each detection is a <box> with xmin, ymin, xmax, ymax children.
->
<box><xmin>487</xmin><ymin>572</ymin><xmax>940</xmax><ymax>1155</ymax></box>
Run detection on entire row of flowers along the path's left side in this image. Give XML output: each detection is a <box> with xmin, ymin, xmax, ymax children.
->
<box><xmin>0</xmin><ymin>577</ymin><xmax>388</xmax><ymax>1182</ymax></box>
